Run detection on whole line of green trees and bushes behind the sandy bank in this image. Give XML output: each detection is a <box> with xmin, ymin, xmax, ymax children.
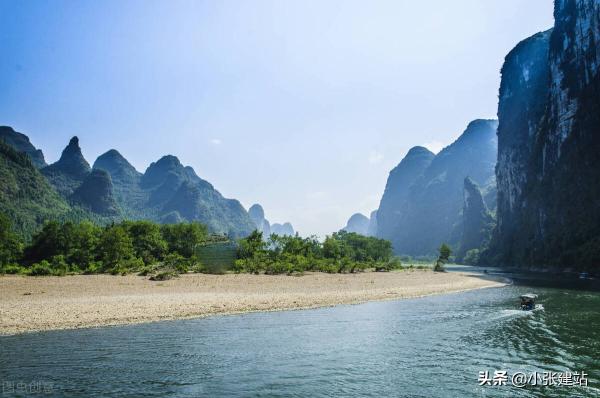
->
<box><xmin>0</xmin><ymin>214</ymin><xmax>400</xmax><ymax>275</ymax></box>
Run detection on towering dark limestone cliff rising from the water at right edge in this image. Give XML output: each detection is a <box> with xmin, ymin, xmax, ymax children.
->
<box><xmin>482</xmin><ymin>0</ymin><xmax>600</xmax><ymax>268</ymax></box>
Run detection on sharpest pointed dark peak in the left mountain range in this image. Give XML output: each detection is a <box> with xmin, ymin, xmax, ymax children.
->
<box><xmin>42</xmin><ymin>137</ymin><xmax>90</xmax><ymax>197</ymax></box>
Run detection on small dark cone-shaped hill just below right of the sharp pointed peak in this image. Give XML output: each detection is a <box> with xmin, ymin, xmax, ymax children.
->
<box><xmin>71</xmin><ymin>169</ymin><xmax>119</xmax><ymax>216</ymax></box>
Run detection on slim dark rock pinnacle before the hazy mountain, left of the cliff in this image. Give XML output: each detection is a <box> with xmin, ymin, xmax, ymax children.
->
<box><xmin>456</xmin><ymin>177</ymin><xmax>494</xmax><ymax>258</ymax></box>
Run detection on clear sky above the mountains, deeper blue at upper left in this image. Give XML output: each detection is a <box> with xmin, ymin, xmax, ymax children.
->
<box><xmin>0</xmin><ymin>0</ymin><xmax>552</xmax><ymax>235</ymax></box>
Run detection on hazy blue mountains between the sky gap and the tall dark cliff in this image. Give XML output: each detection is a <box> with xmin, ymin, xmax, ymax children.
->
<box><xmin>344</xmin><ymin>120</ymin><xmax>498</xmax><ymax>256</ymax></box>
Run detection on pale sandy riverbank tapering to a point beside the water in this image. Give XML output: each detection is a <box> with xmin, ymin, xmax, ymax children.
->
<box><xmin>0</xmin><ymin>270</ymin><xmax>503</xmax><ymax>334</ymax></box>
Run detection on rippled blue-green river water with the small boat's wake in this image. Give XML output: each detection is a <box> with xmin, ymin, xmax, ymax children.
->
<box><xmin>0</xmin><ymin>270</ymin><xmax>600</xmax><ymax>397</ymax></box>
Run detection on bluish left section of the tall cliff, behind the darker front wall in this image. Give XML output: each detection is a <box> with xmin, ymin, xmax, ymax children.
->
<box><xmin>496</xmin><ymin>30</ymin><xmax>551</xmax><ymax>258</ymax></box>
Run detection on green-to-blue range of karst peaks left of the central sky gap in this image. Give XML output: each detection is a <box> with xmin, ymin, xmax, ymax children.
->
<box><xmin>0</xmin><ymin>126</ymin><xmax>255</xmax><ymax>237</ymax></box>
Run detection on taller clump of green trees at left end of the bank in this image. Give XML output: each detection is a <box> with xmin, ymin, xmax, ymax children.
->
<box><xmin>0</xmin><ymin>213</ymin><xmax>216</xmax><ymax>275</ymax></box>
